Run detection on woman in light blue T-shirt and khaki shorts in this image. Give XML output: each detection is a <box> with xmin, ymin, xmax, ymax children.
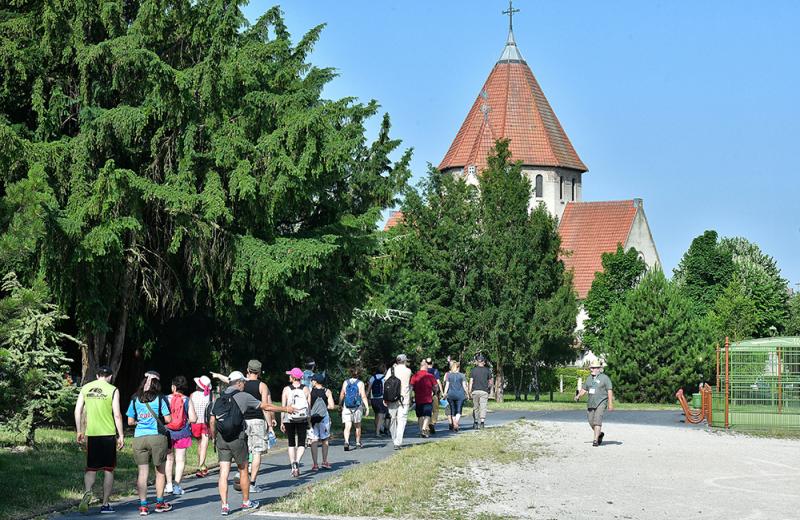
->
<box><xmin>126</xmin><ymin>370</ymin><xmax>172</xmax><ymax>516</ymax></box>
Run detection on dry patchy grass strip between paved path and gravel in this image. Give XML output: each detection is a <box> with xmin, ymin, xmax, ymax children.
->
<box><xmin>270</xmin><ymin>421</ymin><xmax>537</xmax><ymax>520</ymax></box>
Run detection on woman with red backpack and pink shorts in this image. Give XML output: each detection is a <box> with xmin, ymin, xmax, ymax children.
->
<box><xmin>164</xmin><ymin>376</ymin><xmax>197</xmax><ymax>496</ymax></box>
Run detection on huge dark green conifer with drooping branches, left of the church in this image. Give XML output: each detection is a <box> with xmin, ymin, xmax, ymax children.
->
<box><xmin>0</xmin><ymin>0</ymin><xmax>409</xmax><ymax>388</ymax></box>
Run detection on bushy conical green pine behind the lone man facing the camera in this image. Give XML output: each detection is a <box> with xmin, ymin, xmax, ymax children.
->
<box><xmin>605</xmin><ymin>270</ymin><xmax>714</xmax><ymax>402</ymax></box>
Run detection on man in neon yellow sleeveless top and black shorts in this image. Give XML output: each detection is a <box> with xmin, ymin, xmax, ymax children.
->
<box><xmin>75</xmin><ymin>366</ymin><xmax>124</xmax><ymax>513</ymax></box>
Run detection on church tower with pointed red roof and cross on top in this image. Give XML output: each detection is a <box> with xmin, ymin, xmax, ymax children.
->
<box><xmin>439</xmin><ymin>5</ymin><xmax>587</xmax><ymax>218</ymax></box>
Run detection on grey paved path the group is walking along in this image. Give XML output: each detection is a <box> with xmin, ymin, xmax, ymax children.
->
<box><xmin>55</xmin><ymin>410</ymin><xmax>687</xmax><ymax>520</ymax></box>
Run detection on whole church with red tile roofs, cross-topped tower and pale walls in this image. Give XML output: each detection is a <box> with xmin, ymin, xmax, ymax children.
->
<box><xmin>385</xmin><ymin>6</ymin><xmax>661</xmax><ymax>342</ymax></box>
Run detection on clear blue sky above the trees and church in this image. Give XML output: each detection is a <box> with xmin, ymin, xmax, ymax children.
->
<box><xmin>245</xmin><ymin>0</ymin><xmax>800</xmax><ymax>289</ymax></box>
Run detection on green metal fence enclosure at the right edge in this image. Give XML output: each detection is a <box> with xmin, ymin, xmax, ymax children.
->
<box><xmin>711</xmin><ymin>337</ymin><xmax>800</xmax><ymax>430</ymax></box>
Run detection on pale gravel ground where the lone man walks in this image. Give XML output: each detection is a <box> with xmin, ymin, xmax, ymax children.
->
<box><xmin>470</xmin><ymin>418</ymin><xmax>800</xmax><ymax>520</ymax></box>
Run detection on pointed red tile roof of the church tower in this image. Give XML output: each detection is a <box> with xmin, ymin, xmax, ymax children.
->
<box><xmin>439</xmin><ymin>54</ymin><xmax>587</xmax><ymax>172</ymax></box>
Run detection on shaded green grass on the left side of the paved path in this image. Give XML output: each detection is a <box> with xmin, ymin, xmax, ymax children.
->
<box><xmin>0</xmin><ymin>429</ymin><xmax>217</xmax><ymax>519</ymax></box>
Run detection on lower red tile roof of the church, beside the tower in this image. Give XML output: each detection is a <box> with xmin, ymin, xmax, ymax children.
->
<box><xmin>558</xmin><ymin>200</ymin><xmax>638</xmax><ymax>299</ymax></box>
